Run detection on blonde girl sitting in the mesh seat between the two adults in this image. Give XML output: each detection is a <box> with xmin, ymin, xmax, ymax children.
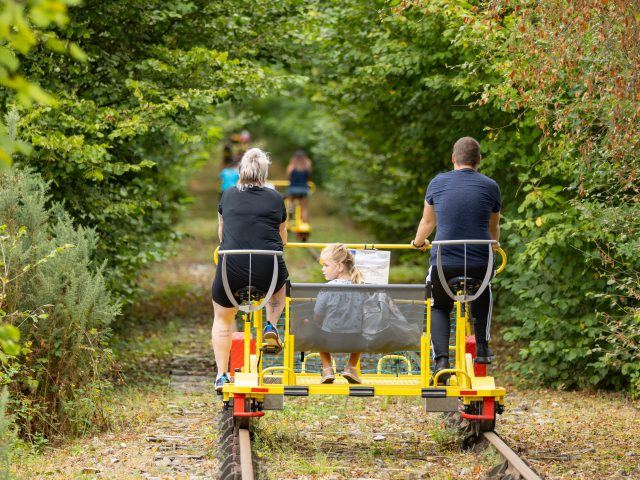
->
<box><xmin>313</xmin><ymin>243</ymin><xmax>364</xmax><ymax>383</ymax></box>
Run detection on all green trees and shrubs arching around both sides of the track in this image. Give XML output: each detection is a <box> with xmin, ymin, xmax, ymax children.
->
<box><xmin>0</xmin><ymin>0</ymin><xmax>640</xmax><ymax>438</ymax></box>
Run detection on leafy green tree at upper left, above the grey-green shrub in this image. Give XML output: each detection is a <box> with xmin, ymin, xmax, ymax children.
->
<box><xmin>0</xmin><ymin>0</ymin><xmax>312</xmax><ymax>297</ymax></box>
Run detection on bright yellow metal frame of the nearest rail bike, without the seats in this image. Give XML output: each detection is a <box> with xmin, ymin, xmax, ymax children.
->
<box><xmin>223</xmin><ymin>243</ymin><xmax>506</xmax><ymax>430</ymax></box>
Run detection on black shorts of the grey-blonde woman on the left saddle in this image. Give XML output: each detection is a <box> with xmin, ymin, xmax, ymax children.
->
<box><xmin>211</xmin><ymin>256</ymin><xmax>289</xmax><ymax>308</ymax></box>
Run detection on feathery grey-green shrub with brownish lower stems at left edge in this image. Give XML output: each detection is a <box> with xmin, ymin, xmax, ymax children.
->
<box><xmin>0</xmin><ymin>169</ymin><xmax>119</xmax><ymax>438</ymax></box>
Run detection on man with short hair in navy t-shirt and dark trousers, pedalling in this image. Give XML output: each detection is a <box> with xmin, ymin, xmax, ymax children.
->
<box><xmin>412</xmin><ymin>137</ymin><xmax>502</xmax><ymax>383</ymax></box>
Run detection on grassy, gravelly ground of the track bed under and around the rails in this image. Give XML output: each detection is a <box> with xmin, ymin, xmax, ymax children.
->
<box><xmin>12</xmin><ymin>158</ymin><xmax>640</xmax><ymax>480</ymax></box>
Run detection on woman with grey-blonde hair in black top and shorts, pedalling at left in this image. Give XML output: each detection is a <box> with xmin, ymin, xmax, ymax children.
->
<box><xmin>211</xmin><ymin>148</ymin><xmax>288</xmax><ymax>392</ymax></box>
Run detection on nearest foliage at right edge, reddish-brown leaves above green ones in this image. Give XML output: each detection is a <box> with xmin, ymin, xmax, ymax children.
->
<box><xmin>464</xmin><ymin>0</ymin><xmax>640</xmax><ymax>395</ymax></box>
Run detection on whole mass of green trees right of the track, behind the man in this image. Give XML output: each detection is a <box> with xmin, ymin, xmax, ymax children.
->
<box><xmin>286</xmin><ymin>0</ymin><xmax>640</xmax><ymax>393</ymax></box>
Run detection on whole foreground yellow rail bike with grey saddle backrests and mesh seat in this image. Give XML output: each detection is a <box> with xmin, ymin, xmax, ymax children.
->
<box><xmin>216</xmin><ymin>240</ymin><xmax>506</xmax><ymax>480</ymax></box>
